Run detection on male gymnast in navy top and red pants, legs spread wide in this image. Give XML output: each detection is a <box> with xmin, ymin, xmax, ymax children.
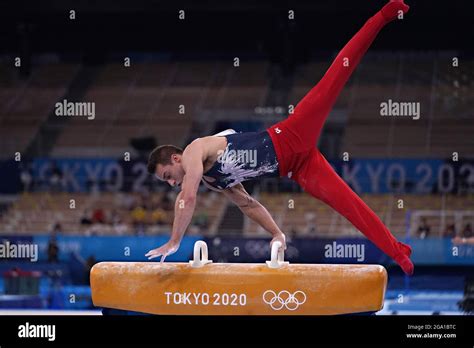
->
<box><xmin>145</xmin><ymin>0</ymin><xmax>414</xmax><ymax>275</ymax></box>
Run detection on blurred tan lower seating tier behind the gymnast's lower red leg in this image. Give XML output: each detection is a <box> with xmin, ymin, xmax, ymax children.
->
<box><xmin>244</xmin><ymin>193</ymin><xmax>474</xmax><ymax>238</ymax></box>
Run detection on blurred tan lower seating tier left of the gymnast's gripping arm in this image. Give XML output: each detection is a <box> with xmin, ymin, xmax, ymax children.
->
<box><xmin>0</xmin><ymin>192</ymin><xmax>226</xmax><ymax>235</ymax></box>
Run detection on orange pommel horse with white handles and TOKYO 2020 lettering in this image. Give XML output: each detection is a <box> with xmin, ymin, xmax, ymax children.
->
<box><xmin>90</xmin><ymin>241</ymin><xmax>387</xmax><ymax>315</ymax></box>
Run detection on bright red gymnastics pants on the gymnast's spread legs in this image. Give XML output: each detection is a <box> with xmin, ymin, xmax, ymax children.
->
<box><xmin>267</xmin><ymin>0</ymin><xmax>413</xmax><ymax>274</ymax></box>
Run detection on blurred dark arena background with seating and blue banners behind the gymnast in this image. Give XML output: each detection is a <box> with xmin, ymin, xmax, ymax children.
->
<box><xmin>0</xmin><ymin>1</ymin><xmax>474</xmax><ymax>314</ymax></box>
